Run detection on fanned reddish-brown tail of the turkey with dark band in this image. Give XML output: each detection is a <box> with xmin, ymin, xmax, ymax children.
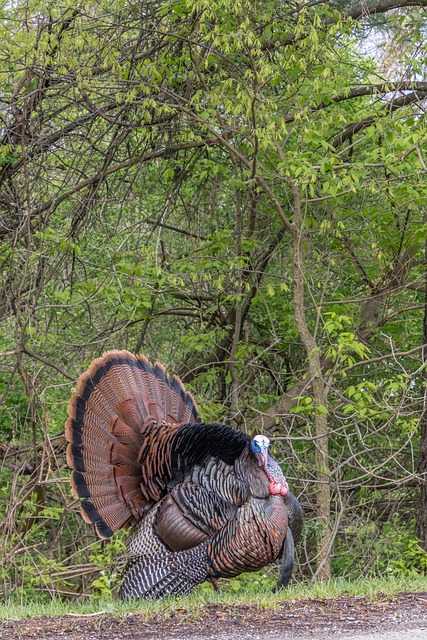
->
<box><xmin>65</xmin><ymin>351</ymin><xmax>200</xmax><ymax>538</ymax></box>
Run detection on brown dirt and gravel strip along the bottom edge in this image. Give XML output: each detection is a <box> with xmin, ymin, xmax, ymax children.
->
<box><xmin>0</xmin><ymin>592</ymin><xmax>427</xmax><ymax>640</ymax></box>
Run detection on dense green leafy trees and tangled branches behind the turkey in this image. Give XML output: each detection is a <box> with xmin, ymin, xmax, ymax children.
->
<box><xmin>0</xmin><ymin>0</ymin><xmax>427</xmax><ymax>598</ymax></box>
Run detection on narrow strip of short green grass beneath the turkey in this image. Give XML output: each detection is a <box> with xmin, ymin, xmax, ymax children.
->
<box><xmin>0</xmin><ymin>576</ymin><xmax>427</xmax><ymax>620</ymax></box>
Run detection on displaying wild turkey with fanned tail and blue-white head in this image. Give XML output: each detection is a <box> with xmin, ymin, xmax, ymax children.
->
<box><xmin>65</xmin><ymin>351</ymin><xmax>302</xmax><ymax>598</ymax></box>
